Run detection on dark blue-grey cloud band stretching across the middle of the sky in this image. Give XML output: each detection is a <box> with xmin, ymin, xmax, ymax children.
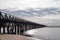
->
<box><xmin>13</xmin><ymin>8</ymin><xmax>60</xmax><ymax>17</ymax></box>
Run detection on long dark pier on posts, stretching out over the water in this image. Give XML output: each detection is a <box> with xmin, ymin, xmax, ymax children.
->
<box><xmin>0</xmin><ymin>12</ymin><xmax>46</xmax><ymax>34</ymax></box>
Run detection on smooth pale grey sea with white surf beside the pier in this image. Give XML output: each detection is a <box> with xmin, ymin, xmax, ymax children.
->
<box><xmin>25</xmin><ymin>28</ymin><xmax>60</xmax><ymax>40</ymax></box>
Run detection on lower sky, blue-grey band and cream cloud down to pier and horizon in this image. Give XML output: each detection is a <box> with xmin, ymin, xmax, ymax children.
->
<box><xmin>0</xmin><ymin>7</ymin><xmax>60</xmax><ymax>26</ymax></box>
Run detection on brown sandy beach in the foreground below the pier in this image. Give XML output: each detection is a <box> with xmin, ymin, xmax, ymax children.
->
<box><xmin>0</xmin><ymin>35</ymin><xmax>30</xmax><ymax>40</ymax></box>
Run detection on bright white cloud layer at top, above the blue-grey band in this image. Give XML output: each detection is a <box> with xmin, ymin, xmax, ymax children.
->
<box><xmin>0</xmin><ymin>0</ymin><xmax>60</xmax><ymax>9</ymax></box>
